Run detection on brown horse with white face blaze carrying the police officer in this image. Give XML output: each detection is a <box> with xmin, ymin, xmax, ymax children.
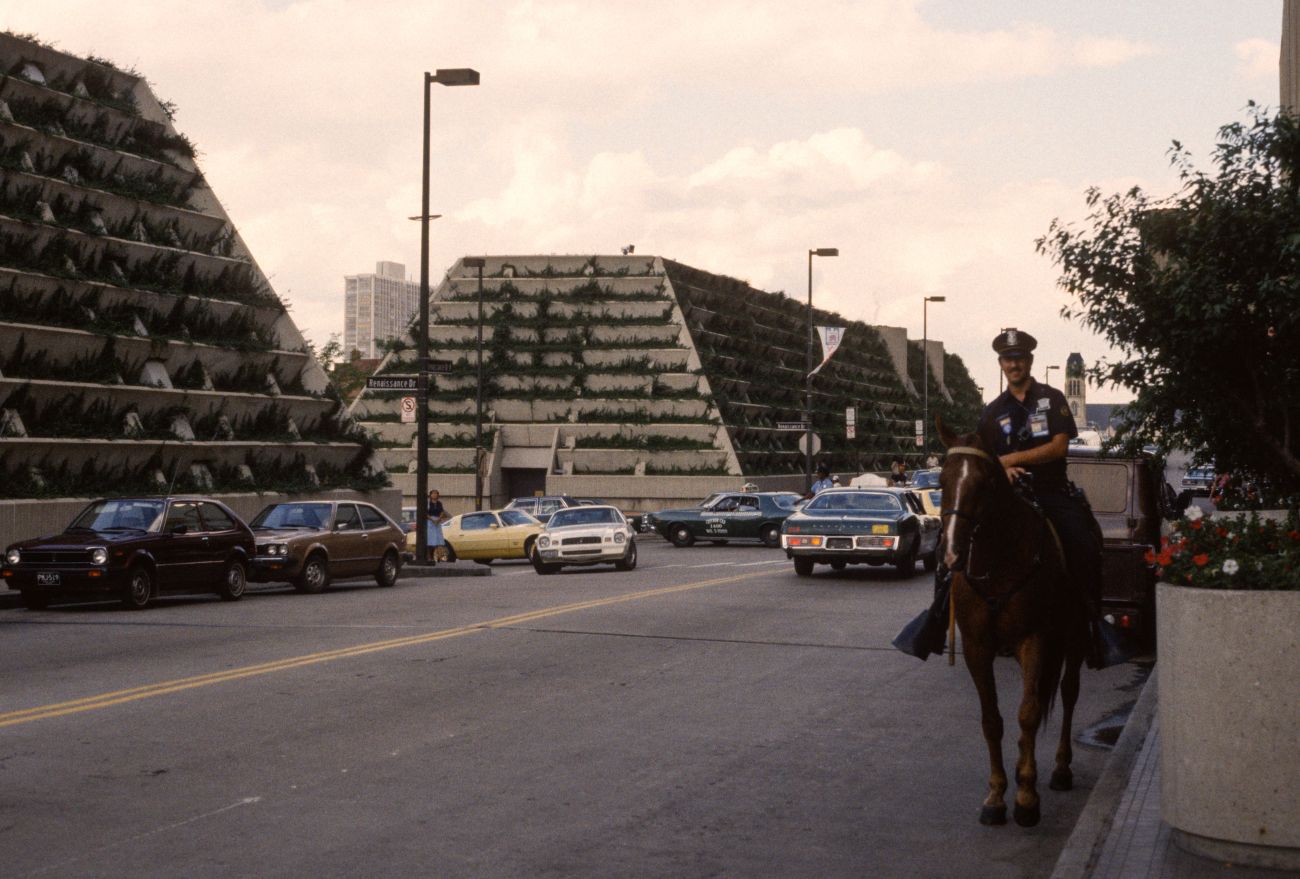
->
<box><xmin>939</xmin><ymin>420</ymin><xmax>1088</xmax><ymax>827</ymax></box>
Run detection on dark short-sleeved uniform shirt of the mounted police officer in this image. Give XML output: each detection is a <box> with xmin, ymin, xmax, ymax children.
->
<box><xmin>976</xmin><ymin>381</ymin><xmax>1079</xmax><ymax>493</ymax></box>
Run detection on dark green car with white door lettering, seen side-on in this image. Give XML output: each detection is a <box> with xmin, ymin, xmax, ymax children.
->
<box><xmin>645</xmin><ymin>490</ymin><xmax>800</xmax><ymax>546</ymax></box>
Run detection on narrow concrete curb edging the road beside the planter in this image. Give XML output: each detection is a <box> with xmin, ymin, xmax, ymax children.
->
<box><xmin>1050</xmin><ymin>670</ymin><xmax>1157</xmax><ymax>879</ymax></box>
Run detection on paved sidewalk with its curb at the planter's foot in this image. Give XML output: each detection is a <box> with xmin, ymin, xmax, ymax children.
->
<box><xmin>1052</xmin><ymin>674</ymin><xmax>1296</xmax><ymax>879</ymax></box>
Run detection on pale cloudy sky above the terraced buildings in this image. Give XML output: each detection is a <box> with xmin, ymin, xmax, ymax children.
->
<box><xmin>0</xmin><ymin>0</ymin><xmax>1282</xmax><ymax>402</ymax></box>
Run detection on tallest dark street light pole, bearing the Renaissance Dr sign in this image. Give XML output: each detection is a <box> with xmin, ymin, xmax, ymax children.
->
<box><xmin>415</xmin><ymin>68</ymin><xmax>478</xmax><ymax>564</ymax></box>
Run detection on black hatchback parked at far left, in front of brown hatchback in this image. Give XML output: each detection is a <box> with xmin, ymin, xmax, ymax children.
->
<box><xmin>0</xmin><ymin>498</ymin><xmax>256</xmax><ymax>610</ymax></box>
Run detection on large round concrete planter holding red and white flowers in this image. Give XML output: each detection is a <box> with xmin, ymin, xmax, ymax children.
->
<box><xmin>1156</xmin><ymin>583</ymin><xmax>1300</xmax><ymax>870</ymax></box>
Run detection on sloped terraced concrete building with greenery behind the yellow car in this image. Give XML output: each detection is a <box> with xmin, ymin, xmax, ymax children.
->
<box><xmin>352</xmin><ymin>256</ymin><xmax>979</xmax><ymax>511</ymax></box>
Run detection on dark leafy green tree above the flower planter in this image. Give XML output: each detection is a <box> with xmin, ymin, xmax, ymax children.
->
<box><xmin>1037</xmin><ymin>103</ymin><xmax>1300</xmax><ymax>495</ymax></box>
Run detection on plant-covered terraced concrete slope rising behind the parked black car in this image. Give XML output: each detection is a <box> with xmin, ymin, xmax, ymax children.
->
<box><xmin>0</xmin><ymin>34</ymin><xmax>386</xmax><ymax>507</ymax></box>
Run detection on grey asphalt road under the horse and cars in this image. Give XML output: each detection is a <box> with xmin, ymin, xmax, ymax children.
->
<box><xmin>0</xmin><ymin>540</ymin><xmax>1148</xmax><ymax>879</ymax></box>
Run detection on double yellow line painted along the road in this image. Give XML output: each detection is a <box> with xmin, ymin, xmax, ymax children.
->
<box><xmin>0</xmin><ymin>571</ymin><xmax>759</xmax><ymax>727</ymax></box>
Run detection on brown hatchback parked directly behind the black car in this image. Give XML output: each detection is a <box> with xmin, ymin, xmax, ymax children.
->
<box><xmin>245</xmin><ymin>501</ymin><xmax>406</xmax><ymax>592</ymax></box>
